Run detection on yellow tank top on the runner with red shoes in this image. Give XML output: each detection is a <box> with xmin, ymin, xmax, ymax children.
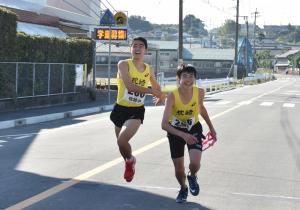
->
<box><xmin>117</xmin><ymin>59</ymin><xmax>150</xmax><ymax>107</ymax></box>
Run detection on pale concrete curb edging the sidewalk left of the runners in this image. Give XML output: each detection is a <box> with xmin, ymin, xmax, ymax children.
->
<box><xmin>0</xmin><ymin>104</ymin><xmax>114</xmax><ymax>130</ymax></box>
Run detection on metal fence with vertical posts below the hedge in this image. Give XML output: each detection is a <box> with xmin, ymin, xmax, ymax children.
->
<box><xmin>0</xmin><ymin>62</ymin><xmax>82</xmax><ymax>100</ymax></box>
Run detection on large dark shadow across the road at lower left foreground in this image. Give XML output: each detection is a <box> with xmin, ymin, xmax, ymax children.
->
<box><xmin>0</xmin><ymin>119</ymin><xmax>209</xmax><ymax>210</ymax></box>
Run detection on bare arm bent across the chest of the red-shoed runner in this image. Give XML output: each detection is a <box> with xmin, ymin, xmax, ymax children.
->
<box><xmin>118</xmin><ymin>60</ymin><xmax>160</xmax><ymax>96</ymax></box>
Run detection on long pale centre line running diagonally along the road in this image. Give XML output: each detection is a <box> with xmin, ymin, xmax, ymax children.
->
<box><xmin>6</xmin><ymin>80</ymin><xmax>290</xmax><ymax>210</ymax></box>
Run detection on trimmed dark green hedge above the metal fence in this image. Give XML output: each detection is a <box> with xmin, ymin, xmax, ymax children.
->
<box><xmin>0</xmin><ymin>7</ymin><xmax>92</xmax><ymax>71</ymax></box>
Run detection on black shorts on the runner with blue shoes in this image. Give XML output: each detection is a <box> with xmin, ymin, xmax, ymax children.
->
<box><xmin>167</xmin><ymin>122</ymin><xmax>205</xmax><ymax>159</ymax></box>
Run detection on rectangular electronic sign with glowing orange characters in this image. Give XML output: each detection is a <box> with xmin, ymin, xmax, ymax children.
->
<box><xmin>95</xmin><ymin>28</ymin><xmax>127</xmax><ymax>41</ymax></box>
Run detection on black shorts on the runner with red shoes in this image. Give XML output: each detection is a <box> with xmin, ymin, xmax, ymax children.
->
<box><xmin>110</xmin><ymin>104</ymin><xmax>145</xmax><ymax>128</ymax></box>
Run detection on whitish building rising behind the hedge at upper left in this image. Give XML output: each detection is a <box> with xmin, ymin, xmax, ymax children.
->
<box><xmin>0</xmin><ymin>0</ymin><xmax>100</xmax><ymax>38</ymax></box>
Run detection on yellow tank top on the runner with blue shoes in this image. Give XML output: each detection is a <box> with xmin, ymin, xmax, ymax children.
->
<box><xmin>169</xmin><ymin>86</ymin><xmax>199</xmax><ymax>130</ymax></box>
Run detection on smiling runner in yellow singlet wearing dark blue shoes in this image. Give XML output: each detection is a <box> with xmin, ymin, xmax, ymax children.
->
<box><xmin>162</xmin><ymin>64</ymin><xmax>216</xmax><ymax>203</ymax></box>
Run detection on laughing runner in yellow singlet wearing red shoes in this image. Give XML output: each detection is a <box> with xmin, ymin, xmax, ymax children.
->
<box><xmin>110</xmin><ymin>37</ymin><xmax>164</xmax><ymax>182</ymax></box>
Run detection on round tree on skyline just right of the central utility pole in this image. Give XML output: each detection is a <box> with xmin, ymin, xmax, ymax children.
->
<box><xmin>183</xmin><ymin>14</ymin><xmax>208</xmax><ymax>37</ymax></box>
